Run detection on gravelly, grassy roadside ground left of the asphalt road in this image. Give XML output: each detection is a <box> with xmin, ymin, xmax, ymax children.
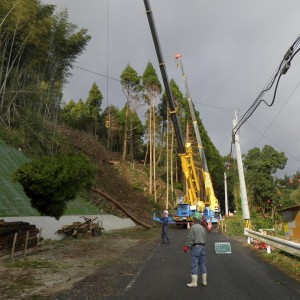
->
<box><xmin>0</xmin><ymin>227</ymin><xmax>160</xmax><ymax>300</ymax></box>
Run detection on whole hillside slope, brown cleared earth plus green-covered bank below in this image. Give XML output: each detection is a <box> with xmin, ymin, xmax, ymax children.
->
<box><xmin>0</xmin><ymin>126</ymin><xmax>163</xmax><ymax>223</ymax></box>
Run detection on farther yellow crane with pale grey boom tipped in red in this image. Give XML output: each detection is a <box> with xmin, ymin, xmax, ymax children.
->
<box><xmin>175</xmin><ymin>54</ymin><xmax>220</xmax><ymax>223</ymax></box>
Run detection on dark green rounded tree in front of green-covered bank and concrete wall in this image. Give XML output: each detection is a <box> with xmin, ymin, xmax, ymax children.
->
<box><xmin>13</xmin><ymin>153</ymin><xmax>95</xmax><ymax>219</ymax></box>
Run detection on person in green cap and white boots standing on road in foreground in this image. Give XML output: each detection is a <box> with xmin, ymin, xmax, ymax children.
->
<box><xmin>183</xmin><ymin>212</ymin><xmax>207</xmax><ymax>287</ymax></box>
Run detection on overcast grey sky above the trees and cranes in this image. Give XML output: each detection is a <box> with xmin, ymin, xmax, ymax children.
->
<box><xmin>42</xmin><ymin>0</ymin><xmax>300</xmax><ymax>176</ymax></box>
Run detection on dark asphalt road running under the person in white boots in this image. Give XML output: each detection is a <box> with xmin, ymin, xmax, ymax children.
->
<box><xmin>105</xmin><ymin>228</ymin><xmax>300</xmax><ymax>300</ymax></box>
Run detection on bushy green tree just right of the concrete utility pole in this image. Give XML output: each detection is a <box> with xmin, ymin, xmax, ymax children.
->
<box><xmin>244</xmin><ymin>145</ymin><xmax>287</xmax><ymax>220</ymax></box>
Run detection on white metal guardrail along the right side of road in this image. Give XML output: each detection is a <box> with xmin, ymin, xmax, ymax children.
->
<box><xmin>244</xmin><ymin>228</ymin><xmax>300</xmax><ymax>257</ymax></box>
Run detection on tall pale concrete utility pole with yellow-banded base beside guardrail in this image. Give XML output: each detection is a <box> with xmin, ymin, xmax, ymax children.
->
<box><xmin>232</xmin><ymin>111</ymin><xmax>251</xmax><ymax>228</ymax></box>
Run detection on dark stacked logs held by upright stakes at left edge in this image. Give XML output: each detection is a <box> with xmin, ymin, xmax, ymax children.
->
<box><xmin>0</xmin><ymin>220</ymin><xmax>40</xmax><ymax>256</ymax></box>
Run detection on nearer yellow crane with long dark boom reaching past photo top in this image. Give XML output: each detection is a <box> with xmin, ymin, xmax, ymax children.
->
<box><xmin>144</xmin><ymin>0</ymin><xmax>219</xmax><ymax>224</ymax></box>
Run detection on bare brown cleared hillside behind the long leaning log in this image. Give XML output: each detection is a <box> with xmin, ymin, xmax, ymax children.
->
<box><xmin>59</xmin><ymin>126</ymin><xmax>159</xmax><ymax>223</ymax></box>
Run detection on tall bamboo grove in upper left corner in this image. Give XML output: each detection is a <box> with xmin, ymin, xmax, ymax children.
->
<box><xmin>0</xmin><ymin>0</ymin><xmax>90</xmax><ymax>152</ymax></box>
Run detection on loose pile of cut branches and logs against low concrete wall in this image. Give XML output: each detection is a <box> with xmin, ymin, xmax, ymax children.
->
<box><xmin>56</xmin><ymin>217</ymin><xmax>103</xmax><ymax>238</ymax></box>
